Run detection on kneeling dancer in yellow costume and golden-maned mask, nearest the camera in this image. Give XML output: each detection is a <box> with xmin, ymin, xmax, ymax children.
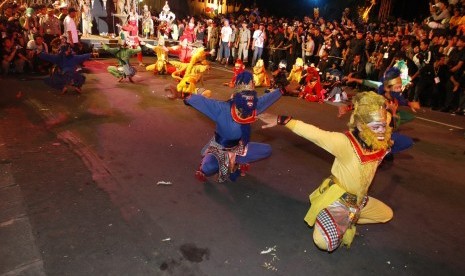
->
<box><xmin>259</xmin><ymin>92</ymin><xmax>393</xmax><ymax>252</ymax></box>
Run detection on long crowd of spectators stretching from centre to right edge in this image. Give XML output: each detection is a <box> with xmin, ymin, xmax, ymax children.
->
<box><xmin>169</xmin><ymin>0</ymin><xmax>465</xmax><ymax>115</ymax></box>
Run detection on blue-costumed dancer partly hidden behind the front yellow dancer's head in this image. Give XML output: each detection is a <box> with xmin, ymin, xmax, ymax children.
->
<box><xmin>347</xmin><ymin>64</ymin><xmax>420</xmax><ymax>159</ymax></box>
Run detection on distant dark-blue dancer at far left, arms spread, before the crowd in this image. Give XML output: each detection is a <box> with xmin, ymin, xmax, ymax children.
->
<box><xmin>39</xmin><ymin>44</ymin><xmax>91</xmax><ymax>94</ymax></box>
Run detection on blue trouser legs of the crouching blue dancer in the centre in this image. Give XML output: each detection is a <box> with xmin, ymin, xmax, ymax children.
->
<box><xmin>200</xmin><ymin>142</ymin><xmax>271</xmax><ymax>176</ymax></box>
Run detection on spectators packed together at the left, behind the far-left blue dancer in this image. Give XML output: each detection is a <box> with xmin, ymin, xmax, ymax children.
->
<box><xmin>0</xmin><ymin>2</ymin><xmax>82</xmax><ymax>75</ymax></box>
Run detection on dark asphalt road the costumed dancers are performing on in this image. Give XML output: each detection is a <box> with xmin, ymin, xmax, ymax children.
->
<box><xmin>0</xmin><ymin>57</ymin><xmax>465</xmax><ymax>275</ymax></box>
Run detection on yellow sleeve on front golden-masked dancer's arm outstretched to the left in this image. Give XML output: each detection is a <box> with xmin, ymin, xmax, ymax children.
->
<box><xmin>286</xmin><ymin>119</ymin><xmax>347</xmax><ymax>160</ymax></box>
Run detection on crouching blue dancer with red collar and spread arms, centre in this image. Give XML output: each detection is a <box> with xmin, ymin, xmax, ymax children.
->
<box><xmin>172</xmin><ymin>71</ymin><xmax>282</xmax><ymax>182</ymax></box>
